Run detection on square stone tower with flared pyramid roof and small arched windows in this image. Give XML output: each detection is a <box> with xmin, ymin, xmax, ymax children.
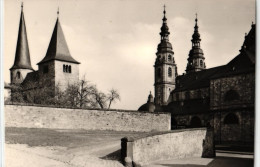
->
<box><xmin>38</xmin><ymin>11</ymin><xmax>80</xmax><ymax>91</ymax></box>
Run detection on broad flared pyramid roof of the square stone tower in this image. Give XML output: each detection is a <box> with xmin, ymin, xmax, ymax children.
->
<box><xmin>38</xmin><ymin>11</ymin><xmax>80</xmax><ymax>64</ymax></box>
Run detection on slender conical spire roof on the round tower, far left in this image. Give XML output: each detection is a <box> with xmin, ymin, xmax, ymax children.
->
<box><xmin>10</xmin><ymin>4</ymin><xmax>33</xmax><ymax>70</ymax></box>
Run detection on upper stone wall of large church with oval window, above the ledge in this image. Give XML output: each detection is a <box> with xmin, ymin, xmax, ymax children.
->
<box><xmin>210</xmin><ymin>73</ymin><xmax>255</xmax><ymax>110</ymax></box>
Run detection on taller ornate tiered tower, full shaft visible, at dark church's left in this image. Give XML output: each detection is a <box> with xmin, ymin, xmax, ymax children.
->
<box><xmin>154</xmin><ymin>6</ymin><xmax>177</xmax><ymax>105</ymax></box>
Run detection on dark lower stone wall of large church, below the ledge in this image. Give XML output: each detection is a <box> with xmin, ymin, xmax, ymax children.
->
<box><xmin>171</xmin><ymin>108</ymin><xmax>255</xmax><ymax>144</ymax></box>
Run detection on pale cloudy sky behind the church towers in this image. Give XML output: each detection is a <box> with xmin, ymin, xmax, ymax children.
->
<box><xmin>3</xmin><ymin>0</ymin><xmax>256</xmax><ymax>110</ymax></box>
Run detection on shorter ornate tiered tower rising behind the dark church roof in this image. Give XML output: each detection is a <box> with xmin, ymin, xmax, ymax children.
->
<box><xmin>186</xmin><ymin>14</ymin><xmax>206</xmax><ymax>73</ymax></box>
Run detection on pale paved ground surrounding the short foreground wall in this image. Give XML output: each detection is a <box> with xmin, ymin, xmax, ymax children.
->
<box><xmin>5</xmin><ymin>128</ymin><xmax>253</xmax><ymax>167</ymax></box>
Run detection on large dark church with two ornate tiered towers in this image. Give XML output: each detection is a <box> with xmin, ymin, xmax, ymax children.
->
<box><xmin>139</xmin><ymin>10</ymin><xmax>256</xmax><ymax>144</ymax></box>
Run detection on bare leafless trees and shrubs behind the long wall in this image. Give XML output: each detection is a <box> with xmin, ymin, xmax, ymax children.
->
<box><xmin>8</xmin><ymin>73</ymin><xmax>120</xmax><ymax>109</ymax></box>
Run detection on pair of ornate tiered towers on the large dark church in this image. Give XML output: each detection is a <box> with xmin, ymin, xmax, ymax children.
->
<box><xmin>154</xmin><ymin>9</ymin><xmax>206</xmax><ymax>105</ymax></box>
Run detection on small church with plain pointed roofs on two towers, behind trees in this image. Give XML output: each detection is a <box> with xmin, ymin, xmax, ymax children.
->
<box><xmin>10</xmin><ymin>6</ymin><xmax>80</xmax><ymax>100</ymax></box>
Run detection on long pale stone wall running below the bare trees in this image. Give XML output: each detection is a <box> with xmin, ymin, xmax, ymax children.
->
<box><xmin>4</xmin><ymin>105</ymin><xmax>171</xmax><ymax>132</ymax></box>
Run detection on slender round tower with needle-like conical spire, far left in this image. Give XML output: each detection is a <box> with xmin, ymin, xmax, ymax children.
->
<box><xmin>10</xmin><ymin>4</ymin><xmax>34</xmax><ymax>84</ymax></box>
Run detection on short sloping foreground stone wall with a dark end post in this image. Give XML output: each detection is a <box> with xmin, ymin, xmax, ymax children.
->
<box><xmin>121</xmin><ymin>128</ymin><xmax>215</xmax><ymax>167</ymax></box>
